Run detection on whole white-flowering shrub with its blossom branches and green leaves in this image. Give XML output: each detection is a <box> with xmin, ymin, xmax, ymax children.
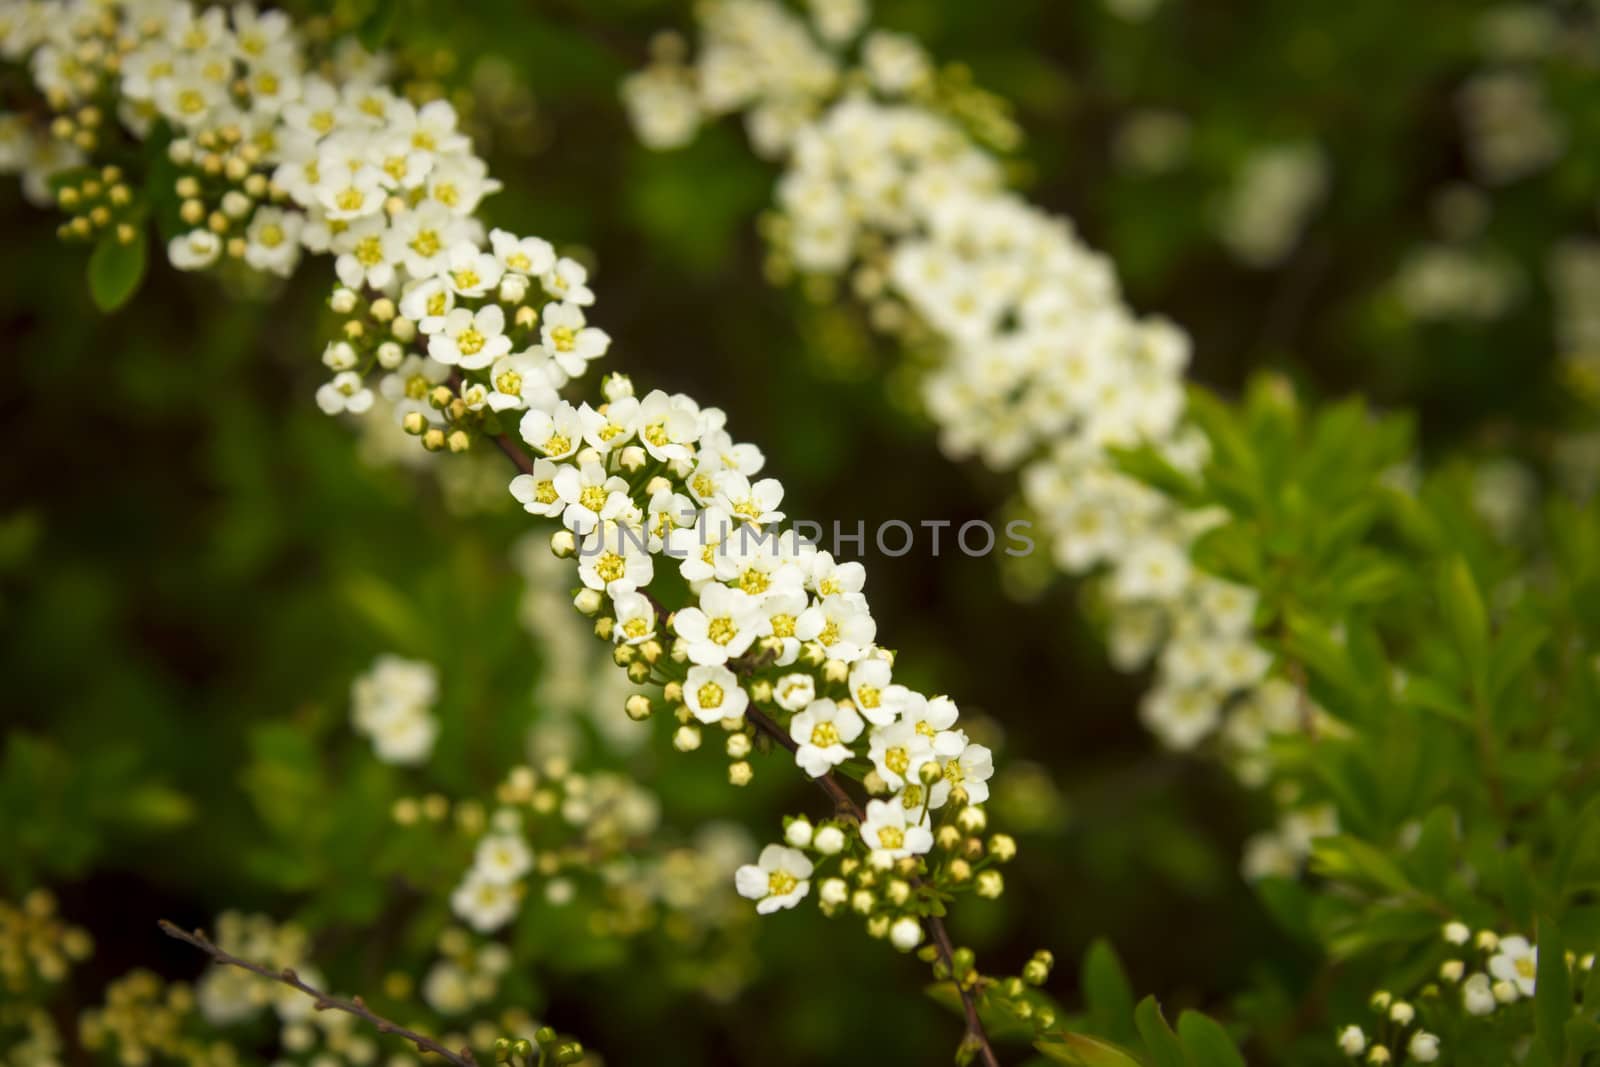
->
<box><xmin>0</xmin><ymin>0</ymin><xmax>1600</xmax><ymax>1067</ymax></box>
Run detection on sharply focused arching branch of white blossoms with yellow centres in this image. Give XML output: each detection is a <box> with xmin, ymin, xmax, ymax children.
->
<box><xmin>0</xmin><ymin>0</ymin><xmax>1030</xmax><ymax>1064</ymax></box>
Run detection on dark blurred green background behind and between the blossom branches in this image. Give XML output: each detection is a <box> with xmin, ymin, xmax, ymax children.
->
<box><xmin>0</xmin><ymin>0</ymin><xmax>1600</xmax><ymax>1064</ymax></box>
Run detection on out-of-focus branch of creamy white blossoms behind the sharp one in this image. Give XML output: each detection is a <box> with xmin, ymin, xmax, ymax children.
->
<box><xmin>627</xmin><ymin>0</ymin><xmax>1323</xmax><ymax>781</ymax></box>
